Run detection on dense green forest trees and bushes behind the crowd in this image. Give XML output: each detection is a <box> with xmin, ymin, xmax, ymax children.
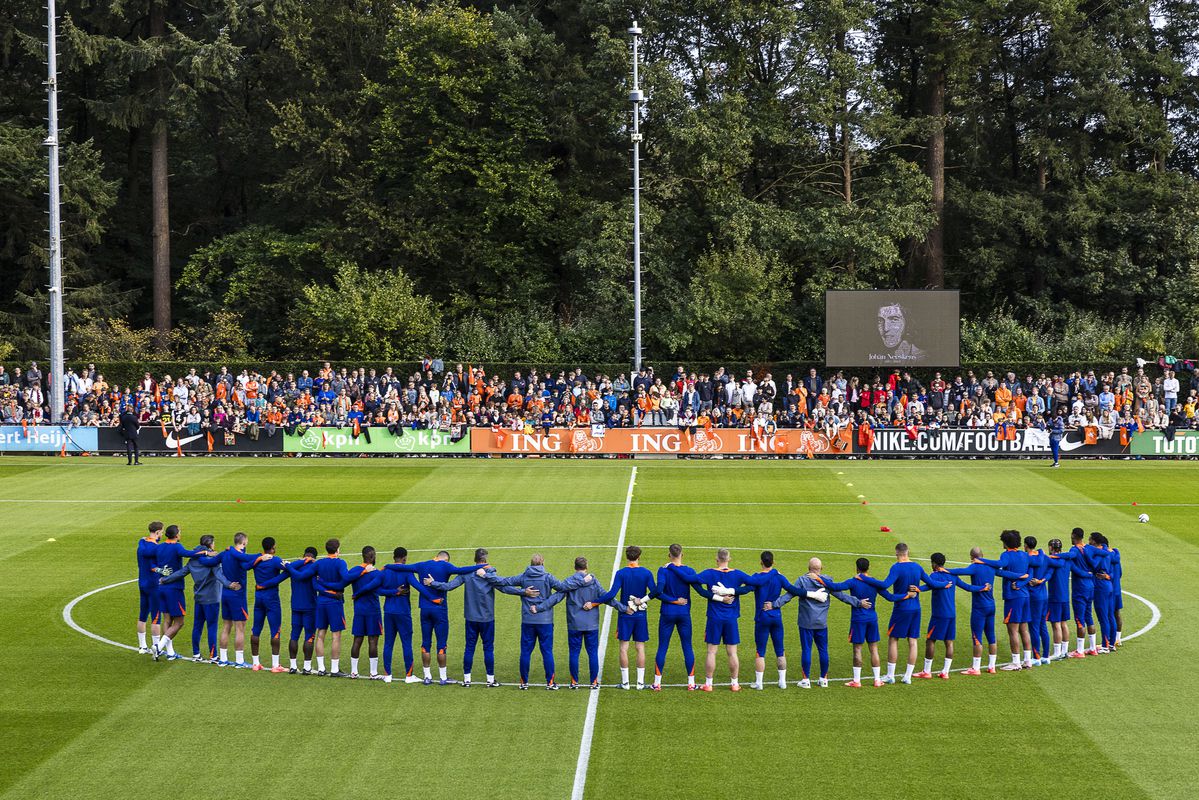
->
<box><xmin>0</xmin><ymin>0</ymin><xmax>1199</xmax><ymax>361</ymax></box>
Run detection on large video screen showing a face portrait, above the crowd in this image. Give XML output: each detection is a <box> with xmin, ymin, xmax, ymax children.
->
<box><xmin>825</xmin><ymin>290</ymin><xmax>959</xmax><ymax>367</ymax></box>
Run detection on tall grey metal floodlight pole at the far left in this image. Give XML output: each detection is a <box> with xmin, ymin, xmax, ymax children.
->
<box><xmin>42</xmin><ymin>0</ymin><xmax>65</xmax><ymax>422</ymax></box>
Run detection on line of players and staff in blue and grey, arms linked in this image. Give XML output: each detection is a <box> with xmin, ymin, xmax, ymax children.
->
<box><xmin>137</xmin><ymin>522</ymin><xmax>1123</xmax><ymax>692</ymax></box>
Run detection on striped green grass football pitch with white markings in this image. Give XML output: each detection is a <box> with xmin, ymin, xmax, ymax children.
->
<box><xmin>0</xmin><ymin>458</ymin><xmax>1199</xmax><ymax>799</ymax></box>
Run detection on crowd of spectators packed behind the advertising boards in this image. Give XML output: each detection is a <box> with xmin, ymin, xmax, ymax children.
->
<box><xmin>0</xmin><ymin>359</ymin><xmax>1199</xmax><ymax>438</ymax></box>
